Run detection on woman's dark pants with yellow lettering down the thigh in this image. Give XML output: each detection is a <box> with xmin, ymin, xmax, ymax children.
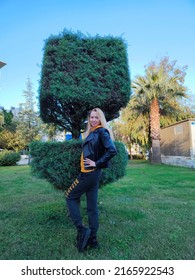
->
<box><xmin>66</xmin><ymin>169</ymin><xmax>101</xmax><ymax>236</ymax></box>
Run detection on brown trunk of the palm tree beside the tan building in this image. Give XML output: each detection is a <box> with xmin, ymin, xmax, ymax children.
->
<box><xmin>150</xmin><ymin>98</ymin><xmax>161</xmax><ymax>163</ymax></box>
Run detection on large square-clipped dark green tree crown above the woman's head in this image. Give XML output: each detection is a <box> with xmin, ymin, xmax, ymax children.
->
<box><xmin>39</xmin><ymin>30</ymin><xmax>130</xmax><ymax>138</ymax></box>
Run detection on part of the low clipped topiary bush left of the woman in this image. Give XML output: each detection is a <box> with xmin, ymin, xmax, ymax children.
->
<box><xmin>30</xmin><ymin>140</ymin><xmax>81</xmax><ymax>189</ymax></box>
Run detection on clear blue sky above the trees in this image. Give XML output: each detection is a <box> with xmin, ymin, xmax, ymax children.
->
<box><xmin>0</xmin><ymin>0</ymin><xmax>195</xmax><ymax>109</ymax></box>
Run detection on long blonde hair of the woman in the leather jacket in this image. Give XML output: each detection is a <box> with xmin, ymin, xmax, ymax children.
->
<box><xmin>85</xmin><ymin>108</ymin><xmax>114</xmax><ymax>140</ymax></box>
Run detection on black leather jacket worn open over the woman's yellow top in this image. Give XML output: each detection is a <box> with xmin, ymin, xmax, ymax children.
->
<box><xmin>83</xmin><ymin>127</ymin><xmax>117</xmax><ymax>170</ymax></box>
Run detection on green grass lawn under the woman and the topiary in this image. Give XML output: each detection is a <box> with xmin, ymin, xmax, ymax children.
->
<box><xmin>0</xmin><ymin>161</ymin><xmax>195</xmax><ymax>260</ymax></box>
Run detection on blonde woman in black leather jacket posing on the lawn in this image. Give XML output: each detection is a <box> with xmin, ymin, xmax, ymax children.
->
<box><xmin>66</xmin><ymin>108</ymin><xmax>117</xmax><ymax>252</ymax></box>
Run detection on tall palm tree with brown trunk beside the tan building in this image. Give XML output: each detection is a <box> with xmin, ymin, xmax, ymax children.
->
<box><xmin>130</xmin><ymin>57</ymin><xmax>187</xmax><ymax>163</ymax></box>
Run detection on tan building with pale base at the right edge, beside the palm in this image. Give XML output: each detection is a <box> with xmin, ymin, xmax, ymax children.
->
<box><xmin>160</xmin><ymin>118</ymin><xmax>195</xmax><ymax>168</ymax></box>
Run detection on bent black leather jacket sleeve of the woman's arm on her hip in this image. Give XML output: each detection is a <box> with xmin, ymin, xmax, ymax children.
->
<box><xmin>96</xmin><ymin>129</ymin><xmax>117</xmax><ymax>168</ymax></box>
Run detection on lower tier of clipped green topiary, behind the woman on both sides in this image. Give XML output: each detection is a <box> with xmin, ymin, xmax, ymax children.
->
<box><xmin>30</xmin><ymin>140</ymin><xmax>128</xmax><ymax>190</ymax></box>
